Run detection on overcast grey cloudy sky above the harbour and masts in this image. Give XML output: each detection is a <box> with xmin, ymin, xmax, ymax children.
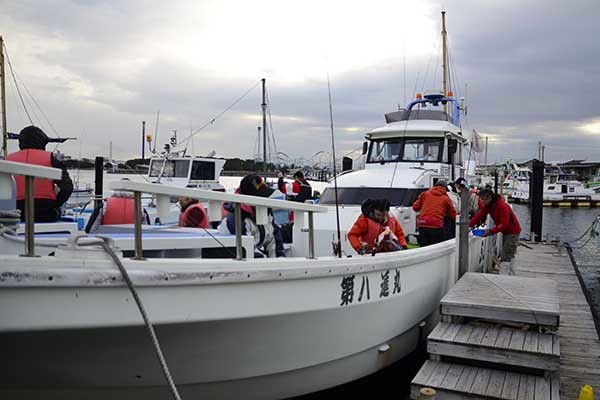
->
<box><xmin>0</xmin><ymin>0</ymin><xmax>600</xmax><ymax>161</ymax></box>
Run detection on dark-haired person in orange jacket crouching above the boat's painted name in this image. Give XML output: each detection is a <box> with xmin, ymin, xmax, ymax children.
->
<box><xmin>347</xmin><ymin>199</ymin><xmax>408</xmax><ymax>254</ymax></box>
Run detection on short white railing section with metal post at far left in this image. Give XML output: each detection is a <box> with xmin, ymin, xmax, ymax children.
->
<box><xmin>0</xmin><ymin>160</ymin><xmax>62</xmax><ymax>257</ymax></box>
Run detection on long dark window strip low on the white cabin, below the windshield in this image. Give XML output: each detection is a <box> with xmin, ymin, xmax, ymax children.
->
<box><xmin>319</xmin><ymin>187</ymin><xmax>427</xmax><ymax>207</ymax></box>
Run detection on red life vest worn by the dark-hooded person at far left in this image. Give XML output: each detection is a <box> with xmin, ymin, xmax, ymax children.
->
<box><xmin>6</xmin><ymin>149</ymin><xmax>56</xmax><ymax>200</ymax></box>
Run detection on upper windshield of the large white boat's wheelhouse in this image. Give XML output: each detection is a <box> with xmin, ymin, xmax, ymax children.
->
<box><xmin>367</xmin><ymin>137</ymin><xmax>444</xmax><ymax>163</ymax></box>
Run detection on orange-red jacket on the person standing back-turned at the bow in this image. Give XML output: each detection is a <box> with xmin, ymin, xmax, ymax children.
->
<box><xmin>413</xmin><ymin>186</ymin><xmax>456</xmax><ymax>228</ymax></box>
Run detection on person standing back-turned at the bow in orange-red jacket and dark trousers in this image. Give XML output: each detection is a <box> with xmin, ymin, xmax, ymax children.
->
<box><xmin>412</xmin><ymin>179</ymin><xmax>456</xmax><ymax>247</ymax></box>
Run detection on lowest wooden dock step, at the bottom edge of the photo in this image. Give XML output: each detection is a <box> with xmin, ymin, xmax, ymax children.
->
<box><xmin>411</xmin><ymin>360</ymin><xmax>560</xmax><ymax>400</ymax></box>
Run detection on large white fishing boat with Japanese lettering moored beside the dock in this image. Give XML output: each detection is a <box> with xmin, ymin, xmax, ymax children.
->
<box><xmin>0</xmin><ymin>10</ymin><xmax>490</xmax><ymax>399</ymax></box>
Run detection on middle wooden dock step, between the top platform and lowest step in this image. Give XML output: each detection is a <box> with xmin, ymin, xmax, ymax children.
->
<box><xmin>427</xmin><ymin>322</ymin><xmax>560</xmax><ymax>371</ymax></box>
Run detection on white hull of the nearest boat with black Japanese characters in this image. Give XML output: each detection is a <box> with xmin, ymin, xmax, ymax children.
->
<box><xmin>0</xmin><ymin>239</ymin><xmax>481</xmax><ymax>399</ymax></box>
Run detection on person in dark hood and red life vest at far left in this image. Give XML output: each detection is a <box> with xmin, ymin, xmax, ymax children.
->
<box><xmin>6</xmin><ymin>125</ymin><xmax>73</xmax><ymax>222</ymax></box>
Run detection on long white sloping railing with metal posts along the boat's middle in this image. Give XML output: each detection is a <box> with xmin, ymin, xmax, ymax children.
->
<box><xmin>109</xmin><ymin>181</ymin><xmax>327</xmax><ymax>260</ymax></box>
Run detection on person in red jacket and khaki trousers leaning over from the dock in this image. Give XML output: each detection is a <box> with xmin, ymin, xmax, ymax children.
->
<box><xmin>469</xmin><ymin>188</ymin><xmax>521</xmax><ymax>261</ymax></box>
